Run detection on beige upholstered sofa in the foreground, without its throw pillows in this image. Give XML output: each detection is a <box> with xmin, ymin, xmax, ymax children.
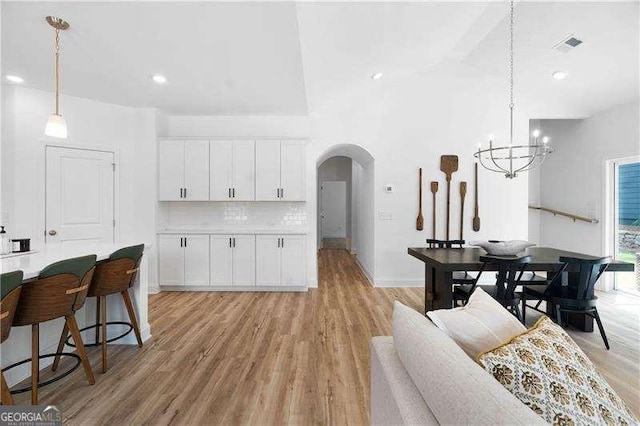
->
<box><xmin>371</xmin><ymin>302</ymin><xmax>545</xmax><ymax>425</ymax></box>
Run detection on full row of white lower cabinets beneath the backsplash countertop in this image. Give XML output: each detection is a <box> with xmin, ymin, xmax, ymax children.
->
<box><xmin>158</xmin><ymin>234</ymin><xmax>306</xmax><ymax>290</ymax></box>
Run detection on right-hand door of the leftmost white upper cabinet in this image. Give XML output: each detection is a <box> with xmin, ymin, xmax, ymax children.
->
<box><xmin>184</xmin><ymin>141</ymin><xmax>209</xmax><ymax>201</ymax></box>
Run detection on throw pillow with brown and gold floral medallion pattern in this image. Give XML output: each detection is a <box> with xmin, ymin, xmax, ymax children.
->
<box><xmin>477</xmin><ymin>317</ymin><xmax>639</xmax><ymax>425</ymax></box>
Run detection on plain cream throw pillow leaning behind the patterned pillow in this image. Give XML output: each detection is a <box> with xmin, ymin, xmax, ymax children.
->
<box><xmin>427</xmin><ymin>287</ymin><xmax>527</xmax><ymax>359</ymax></box>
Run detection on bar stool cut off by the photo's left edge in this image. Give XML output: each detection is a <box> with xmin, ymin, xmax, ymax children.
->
<box><xmin>0</xmin><ymin>271</ymin><xmax>22</xmax><ymax>405</ymax></box>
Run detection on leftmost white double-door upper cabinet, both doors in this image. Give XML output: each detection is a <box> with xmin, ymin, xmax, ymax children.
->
<box><xmin>158</xmin><ymin>140</ymin><xmax>209</xmax><ymax>201</ymax></box>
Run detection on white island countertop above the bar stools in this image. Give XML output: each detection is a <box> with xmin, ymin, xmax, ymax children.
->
<box><xmin>0</xmin><ymin>242</ymin><xmax>150</xmax><ymax>280</ymax></box>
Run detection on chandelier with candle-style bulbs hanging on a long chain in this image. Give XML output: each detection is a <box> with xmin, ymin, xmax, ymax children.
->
<box><xmin>473</xmin><ymin>0</ymin><xmax>554</xmax><ymax>179</ymax></box>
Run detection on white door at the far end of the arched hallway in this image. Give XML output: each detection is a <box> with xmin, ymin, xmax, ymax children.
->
<box><xmin>320</xmin><ymin>181</ymin><xmax>347</xmax><ymax>238</ymax></box>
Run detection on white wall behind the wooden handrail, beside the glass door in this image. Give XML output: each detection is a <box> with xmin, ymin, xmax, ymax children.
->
<box><xmin>531</xmin><ymin>102</ymin><xmax>640</xmax><ymax>256</ymax></box>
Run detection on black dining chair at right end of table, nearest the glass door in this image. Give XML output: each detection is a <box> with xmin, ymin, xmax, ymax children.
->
<box><xmin>522</xmin><ymin>256</ymin><xmax>611</xmax><ymax>350</ymax></box>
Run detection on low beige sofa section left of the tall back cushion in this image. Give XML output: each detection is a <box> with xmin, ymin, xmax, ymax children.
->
<box><xmin>371</xmin><ymin>336</ymin><xmax>438</xmax><ymax>425</ymax></box>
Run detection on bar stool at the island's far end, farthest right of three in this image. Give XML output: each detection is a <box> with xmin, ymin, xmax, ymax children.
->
<box><xmin>51</xmin><ymin>244</ymin><xmax>144</xmax><ymax>373</ymax></box>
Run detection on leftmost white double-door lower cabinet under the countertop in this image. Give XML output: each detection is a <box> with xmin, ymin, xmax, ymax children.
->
<box><xmin>158</xmin><ymin>235</ymin><xmax>209</xmax><ymax>286</ymax></box>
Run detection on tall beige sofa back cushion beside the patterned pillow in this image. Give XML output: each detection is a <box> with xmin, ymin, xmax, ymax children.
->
<box><xmin>393</xmin><ymin>302</ymin><xmax>545</xmax><ymax>425</ymax></box>
